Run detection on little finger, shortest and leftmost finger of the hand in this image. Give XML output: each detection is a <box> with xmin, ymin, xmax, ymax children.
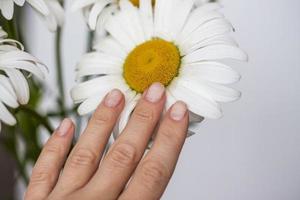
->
<box><xmin>25</xmin><ymin>119</ymin><xmax>74</xmax><ymax>200</ymax></box>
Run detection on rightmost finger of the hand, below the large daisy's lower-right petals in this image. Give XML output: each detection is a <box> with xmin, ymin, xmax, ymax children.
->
<box><xmin>119</xmin><ymin>102</ymin><xmax>188</xmax><ymax>200</ymax></box>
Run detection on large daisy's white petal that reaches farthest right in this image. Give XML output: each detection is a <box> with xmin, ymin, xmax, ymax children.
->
<box><xmin>182</xmin><ymin>45</ymin><xmax>248</xmax><ymax>64</ymax></box>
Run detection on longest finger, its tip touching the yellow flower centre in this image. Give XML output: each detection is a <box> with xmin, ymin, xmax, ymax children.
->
<box><xmin>83</xmin><ymin>83</ymin><xmax>165</xmax><ymax>199</ymax></box>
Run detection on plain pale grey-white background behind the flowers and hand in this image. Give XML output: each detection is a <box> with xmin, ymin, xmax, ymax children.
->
<box><xmin>23</xmin><ymin>0</ymin><xmax>300</xmax><ymax>200</ymax></box>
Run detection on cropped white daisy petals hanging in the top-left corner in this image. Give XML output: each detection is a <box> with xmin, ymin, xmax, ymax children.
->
<box><xmin>0</xmin><ymin>0</ymin><xmax>64</xmax><ymax>31</ymax></box>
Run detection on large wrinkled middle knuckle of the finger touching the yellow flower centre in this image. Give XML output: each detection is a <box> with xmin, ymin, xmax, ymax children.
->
<box><xmin>110</xmin><ymin>144</ymin><xmax>136</xmax><ymax>168</ymax></box>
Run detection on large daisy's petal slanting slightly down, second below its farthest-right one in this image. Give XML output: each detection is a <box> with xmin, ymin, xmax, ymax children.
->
<box><xmin>178</xmin><ymin>77</ymin><xmax>241</xmax><ymax>102</ymax></box>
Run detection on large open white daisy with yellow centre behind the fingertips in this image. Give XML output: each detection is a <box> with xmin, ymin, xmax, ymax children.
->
<box><xmin>71</xmin><ymin>0</ymin><xmax>247</xmax><ymax>136</ymax></box>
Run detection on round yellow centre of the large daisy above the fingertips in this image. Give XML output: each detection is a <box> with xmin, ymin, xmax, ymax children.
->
<box><xmin>123</xmin><ymin>39</ymin><xmax>181</xmax><ymax>93</ymax></box>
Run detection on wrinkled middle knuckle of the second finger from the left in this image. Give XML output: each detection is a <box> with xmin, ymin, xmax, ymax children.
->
<box><xmin>70</xmin><ymin>148</ymin><xmax>97</xmax><ymax>168</ymax></box>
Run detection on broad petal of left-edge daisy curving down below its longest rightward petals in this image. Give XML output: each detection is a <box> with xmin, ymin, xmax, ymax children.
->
<box><xmin>4</xmin><ymin>69</ymin><xmax>29</xmax><ymax>105</ymax></box>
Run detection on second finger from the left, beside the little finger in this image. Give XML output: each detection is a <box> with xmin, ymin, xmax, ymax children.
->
<box><xmin>57</xmin><ymin>90</ymin><xmax>124</xmax><ymax>193</ymax></box>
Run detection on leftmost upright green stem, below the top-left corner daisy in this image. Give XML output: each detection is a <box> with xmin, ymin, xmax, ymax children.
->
<box><xmin>55</xmin><ymin>27</ymin><xmax>66</xmax><ymax>118</ymax></box>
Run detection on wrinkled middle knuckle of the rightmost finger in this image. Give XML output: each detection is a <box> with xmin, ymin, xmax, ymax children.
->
<box><xmin>141</xmin><ymin>161</ymin><xmax>169</xmax><ymax>191</ymax></box>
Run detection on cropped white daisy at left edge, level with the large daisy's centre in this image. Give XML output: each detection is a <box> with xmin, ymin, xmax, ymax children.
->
<box><xmin>0</xmin><ymin>26</ymin><xmax>45</xmax><ymax>131</ymax></box>
